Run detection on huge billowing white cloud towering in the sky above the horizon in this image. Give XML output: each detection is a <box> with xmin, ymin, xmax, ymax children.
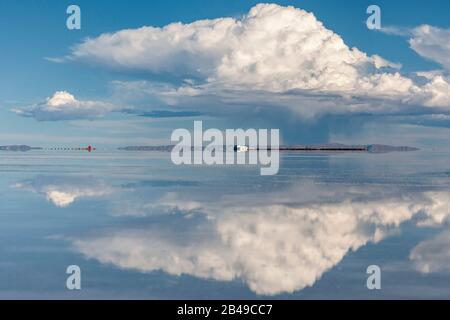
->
<box><xmin>71</xmin><ymin>4</ymin><xmax>450</xmax><ymax>115</ymax></box>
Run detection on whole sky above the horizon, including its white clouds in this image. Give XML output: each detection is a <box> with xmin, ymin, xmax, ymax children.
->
<box><xmin>0</xmin><ymin>0</ymin><xmax>450</xmax><ymax>148</ymax></box>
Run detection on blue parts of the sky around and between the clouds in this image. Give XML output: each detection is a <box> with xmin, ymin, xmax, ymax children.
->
<box><xmin>0</xmin><ymin>0</ymin><xmax>450</xmax><ymax>146</ymax></box>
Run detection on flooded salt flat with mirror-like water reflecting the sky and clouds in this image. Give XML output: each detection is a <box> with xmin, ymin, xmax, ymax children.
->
<box><xmin>0</xmin><ymin>151</ymin><xmax>450</xmax><ymax>299</ymax></box>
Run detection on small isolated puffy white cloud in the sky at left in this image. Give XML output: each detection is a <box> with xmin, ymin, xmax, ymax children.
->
<box><xmin>12</xmin><ymin>91</ymin><xmax>119</xmax><ymax>121</ymax></box>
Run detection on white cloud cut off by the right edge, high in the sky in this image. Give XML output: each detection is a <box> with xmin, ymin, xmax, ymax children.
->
<box><xmin>409</xmin><ymin>25</ymin><xmax>450</xmax><ymax>70</ymax></box>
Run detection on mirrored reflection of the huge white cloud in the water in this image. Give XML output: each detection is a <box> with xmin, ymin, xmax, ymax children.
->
<box><xmin>73</xmin><ymin>186</ymin><xmax>450</xmax><ymax>295</ymax></box>
